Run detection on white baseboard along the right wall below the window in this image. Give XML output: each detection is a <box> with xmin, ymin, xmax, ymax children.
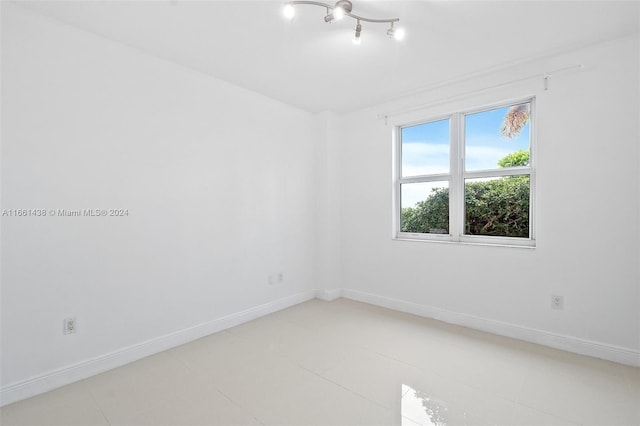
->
<box><xmin>340</xmin><ymin>289</ymin><xmax>640</xmax><ymax>367</ymax></box>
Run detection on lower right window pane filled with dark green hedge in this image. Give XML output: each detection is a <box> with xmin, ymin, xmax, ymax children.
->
<box><xmin>464</xmin><ymin>175</ymin><xmax>530</xmax><ymax>238</ymax></box>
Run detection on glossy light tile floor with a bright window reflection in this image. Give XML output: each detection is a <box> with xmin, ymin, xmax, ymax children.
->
<box><xmin>0</xmin><ymin>299</ymin><xmax>640</xmax><ymax>426</ymax></box>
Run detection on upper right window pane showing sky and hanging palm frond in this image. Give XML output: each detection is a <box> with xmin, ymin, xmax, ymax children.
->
<box><xmin>464</xmin><ymin>102</ymin><xmax>531</xmax><ymax>171</ymax></box>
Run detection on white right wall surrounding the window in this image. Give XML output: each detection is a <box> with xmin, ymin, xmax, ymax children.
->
<box><xmin>334</xmin><ymin>38</ymin><xmax>640</xmax><ymax>365</ymax></box>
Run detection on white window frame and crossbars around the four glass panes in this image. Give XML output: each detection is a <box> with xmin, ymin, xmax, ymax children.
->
<box><xmin>393</xmin><ymin>96</ymin><xmax>537</xmax><ymax>247</ymax></box>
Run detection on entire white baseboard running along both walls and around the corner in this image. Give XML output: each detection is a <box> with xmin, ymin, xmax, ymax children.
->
<box><xmin>0</xmin><ymin>288</ymin><xmax>640</xmax><ymax>407</ymax></box>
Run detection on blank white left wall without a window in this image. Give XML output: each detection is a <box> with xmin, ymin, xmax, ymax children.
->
<box><xmin>1</xmin><ymin>4</ymin><xmax>319</xmax><ymax>403</ymax></box>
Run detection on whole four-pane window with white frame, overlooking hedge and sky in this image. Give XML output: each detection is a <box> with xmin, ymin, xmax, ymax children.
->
<box><xmin>395</xmin><ymin>99</ymin><xmax>535</xmax><ymax>246</ymax></box>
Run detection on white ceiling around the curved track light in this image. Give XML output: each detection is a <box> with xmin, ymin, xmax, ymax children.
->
<box><xmin>11</xmin><ymin>0</ymin><xmax>640</xmax><ymax>112</ymax></box>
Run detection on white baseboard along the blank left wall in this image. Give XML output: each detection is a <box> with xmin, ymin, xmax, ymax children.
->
<box><xmin>0</xmin><ymin>290</ymin><xmax>316</xmax><ymax>407</ymax></box>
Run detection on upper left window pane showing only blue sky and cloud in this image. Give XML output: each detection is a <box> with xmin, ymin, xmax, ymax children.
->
<box><xmin>401</xmin><ymin>119</ymin><xmax>449</xmax><ymax>177</ymax></box>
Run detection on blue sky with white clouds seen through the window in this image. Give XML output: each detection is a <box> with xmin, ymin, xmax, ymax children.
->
<box><xmin>402</xmin><ymin>106</ymin><xmax>530</xmax><ymax>207</ymax></box>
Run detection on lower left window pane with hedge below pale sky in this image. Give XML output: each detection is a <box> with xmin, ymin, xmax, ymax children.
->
<box><xmin>400</xmin><ymin>181</ymin><xmax>449</xmax><ymax>234</ymax></box>
